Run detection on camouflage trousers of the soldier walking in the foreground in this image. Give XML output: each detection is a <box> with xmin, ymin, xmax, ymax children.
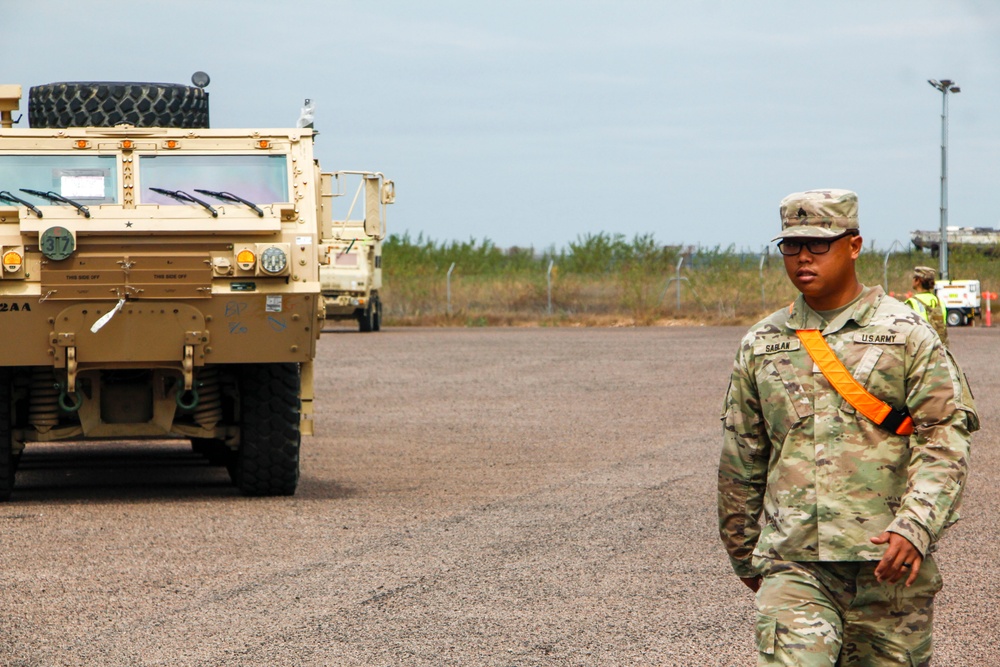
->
<box><xmin>754</xmin><ymin>556</ymin><xmax>941</xmax><ymax>667</ymax></box>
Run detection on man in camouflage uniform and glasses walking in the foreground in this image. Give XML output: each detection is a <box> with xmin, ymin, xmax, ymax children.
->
<box><xmin>718</xmin><ymin>190</ymin><xmax>979</xmax><ymax>667</ymax></box>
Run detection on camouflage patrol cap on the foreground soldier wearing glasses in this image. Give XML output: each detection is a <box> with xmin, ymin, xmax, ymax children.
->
<box><xmin>771</xmin><ymin>190</ymin><xmax>858</xmax><ymax>241</ymax></box>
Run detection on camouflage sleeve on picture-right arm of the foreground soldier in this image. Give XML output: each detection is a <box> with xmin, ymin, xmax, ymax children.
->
<box><xmin>887</xmin><ymin>337</ymin><xmax>979</xmax><ymax>556</ymax></box>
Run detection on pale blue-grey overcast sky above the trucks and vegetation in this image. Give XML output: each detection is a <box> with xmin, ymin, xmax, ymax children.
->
<box><xmin>7</xmin><ymin>0</ymin><xmax>1000</xmax><ymax>250</ymax></box>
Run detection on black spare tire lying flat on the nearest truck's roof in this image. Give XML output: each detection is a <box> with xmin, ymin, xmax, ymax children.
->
<box><xmin>28</xmin><ymin>81</ymin><xmax>208</xmax><ymax>128</ymax></box>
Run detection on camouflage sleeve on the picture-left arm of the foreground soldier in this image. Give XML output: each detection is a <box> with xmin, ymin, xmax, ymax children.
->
<box><xmin>718</xmin><ymin>334</ymin><xmax>771</xmax><ymax>577</ymax></box>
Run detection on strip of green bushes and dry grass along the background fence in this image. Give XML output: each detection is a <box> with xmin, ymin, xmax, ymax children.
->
<box><xmin>383</xmin><ymin>232</ymin><xmax>1000</xmax><ymax>326</ymax></box>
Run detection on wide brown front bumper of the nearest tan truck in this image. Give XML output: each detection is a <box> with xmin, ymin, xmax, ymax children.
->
<box><xmin>0</xmin><ymin>293</ymin><xmax>321</xmax><ymax>368</ymax></box>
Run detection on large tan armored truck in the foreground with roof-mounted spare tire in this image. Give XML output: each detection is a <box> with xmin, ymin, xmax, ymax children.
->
<box><xmin>0</xmin><ymin>73</ymin><xmax>323</xmax><ymax>499</ymax></box>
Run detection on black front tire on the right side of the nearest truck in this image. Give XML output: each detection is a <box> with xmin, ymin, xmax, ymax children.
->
<box><xmin>229</xmin><ymin>364</ymin><xmax>302</xmax><ymax>496</ymax></box>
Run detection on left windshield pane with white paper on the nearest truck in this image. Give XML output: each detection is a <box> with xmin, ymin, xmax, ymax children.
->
<box><xmin>0</xmin><ymin>154</ymin><xmax>118</xmax><ymax>206</ymax></box>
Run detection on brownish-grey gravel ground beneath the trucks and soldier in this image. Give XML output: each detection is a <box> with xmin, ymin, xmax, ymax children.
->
<box><xmin>0</xmin><ymin>327</ymin><xmax>1000</xmax><ymax>667</ymax></box>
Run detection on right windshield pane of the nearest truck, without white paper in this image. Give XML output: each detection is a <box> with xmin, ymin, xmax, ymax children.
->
<box><xmin>139</xmin><ymin>155</ymin><xmax>290</xmax><ymax>206</ymax></box>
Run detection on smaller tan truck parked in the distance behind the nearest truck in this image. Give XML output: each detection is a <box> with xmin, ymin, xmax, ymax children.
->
<box><xmin>319</xmin><ymin>171</ymin><xmax>396</xmax><ymax>332</ymax></box>
